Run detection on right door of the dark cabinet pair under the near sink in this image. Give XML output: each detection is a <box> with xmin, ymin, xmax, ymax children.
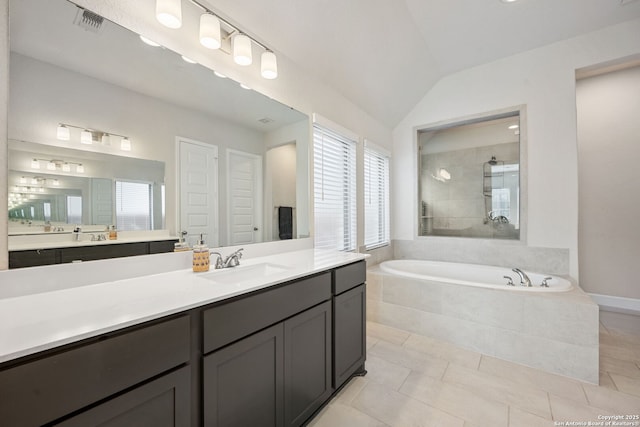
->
<box><xmin>284</xmin><ymin>301</ymin><xmax>333</xmax><ymax>426</ymax></box>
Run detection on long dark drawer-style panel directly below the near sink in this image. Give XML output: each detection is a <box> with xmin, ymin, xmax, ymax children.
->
<box><xmin>203</xmin><ymin>272</ymin><xmax>331</xmax><ymax>353</ymax></box>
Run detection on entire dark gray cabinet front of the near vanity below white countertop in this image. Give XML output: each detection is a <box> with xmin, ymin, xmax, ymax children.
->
<box><xmin>0</xmin><ymin>262</ymin><xmax>365</xmax><ymax>427</ymax></box>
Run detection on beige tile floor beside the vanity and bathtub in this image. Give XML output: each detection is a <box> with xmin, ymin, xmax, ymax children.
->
<box><xmin>309</xmin><ymin>311</ymin><xmax>640</xmax><ymax>427</ymax></box>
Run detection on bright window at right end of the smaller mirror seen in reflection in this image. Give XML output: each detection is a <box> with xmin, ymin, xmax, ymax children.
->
<box><xmin>116</xmin><ymin>181</ymin><xmax>153</xmax><ymax>230</ymax></box>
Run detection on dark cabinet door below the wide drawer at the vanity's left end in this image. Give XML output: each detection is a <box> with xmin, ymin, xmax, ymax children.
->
<box><xmin>54</xmin><ymin>367</ymin><xmax>191</xmax><ymax>427</ymax></box>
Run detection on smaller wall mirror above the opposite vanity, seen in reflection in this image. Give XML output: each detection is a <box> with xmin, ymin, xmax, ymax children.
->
<box><xmin>8</xmin><ymin>140</ymin><xmax>164</xmax><ymax>235</ymax></box>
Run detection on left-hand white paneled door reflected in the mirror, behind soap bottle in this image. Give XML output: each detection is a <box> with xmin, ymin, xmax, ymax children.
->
<box><xmin>177</xmin><ymin>138</ymin><xmax>220</xmax><ymax>247</ymax></box>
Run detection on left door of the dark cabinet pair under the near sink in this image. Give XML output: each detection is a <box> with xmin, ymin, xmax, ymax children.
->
<box><xmin>203</xmin><ymin>323</ymin><xmax>284</xmax><ymax>427</ymax></box>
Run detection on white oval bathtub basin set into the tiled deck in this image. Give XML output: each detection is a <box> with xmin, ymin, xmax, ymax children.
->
<box><xmin>380</xmin><ymin>259</ymin><xmax>572</xmax><ymax>292</ymax></box>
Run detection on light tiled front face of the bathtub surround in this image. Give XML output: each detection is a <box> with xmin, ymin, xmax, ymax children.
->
<box><xmin>367</xmin><ymin>267</ymin><xmax>599</xmax><ymax>384</ymax></box>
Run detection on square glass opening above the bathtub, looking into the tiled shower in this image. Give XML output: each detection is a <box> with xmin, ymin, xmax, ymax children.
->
<box><xmin>418</xmin><ymin>111</ymin><xmax>522</xmax><ymax>240</ymax></box>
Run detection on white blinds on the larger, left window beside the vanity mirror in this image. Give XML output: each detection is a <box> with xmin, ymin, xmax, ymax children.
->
<box><xmin>313</xmin><ymin>124</ymin><xmax>357</xmax><ymax>251</ymax></box>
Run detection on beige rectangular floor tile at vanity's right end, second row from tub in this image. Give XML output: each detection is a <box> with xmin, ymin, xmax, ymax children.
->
<box><xmin>368</xmin><ymin>341</ymin><xmax>449</xmax><ymax>378</ymax></box>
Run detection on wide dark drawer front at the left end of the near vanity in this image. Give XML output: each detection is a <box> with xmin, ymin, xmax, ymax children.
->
<box><xmin>0</xmin><ymin>316</ymin><xmax>190</xmax><ymax>425</ymax></box>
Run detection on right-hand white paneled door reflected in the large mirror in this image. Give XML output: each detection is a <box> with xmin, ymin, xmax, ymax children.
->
<box><xmin>227</xmin><ymin>150</ymin><xmax>262</xmax><ymax>245</ymax></box>
